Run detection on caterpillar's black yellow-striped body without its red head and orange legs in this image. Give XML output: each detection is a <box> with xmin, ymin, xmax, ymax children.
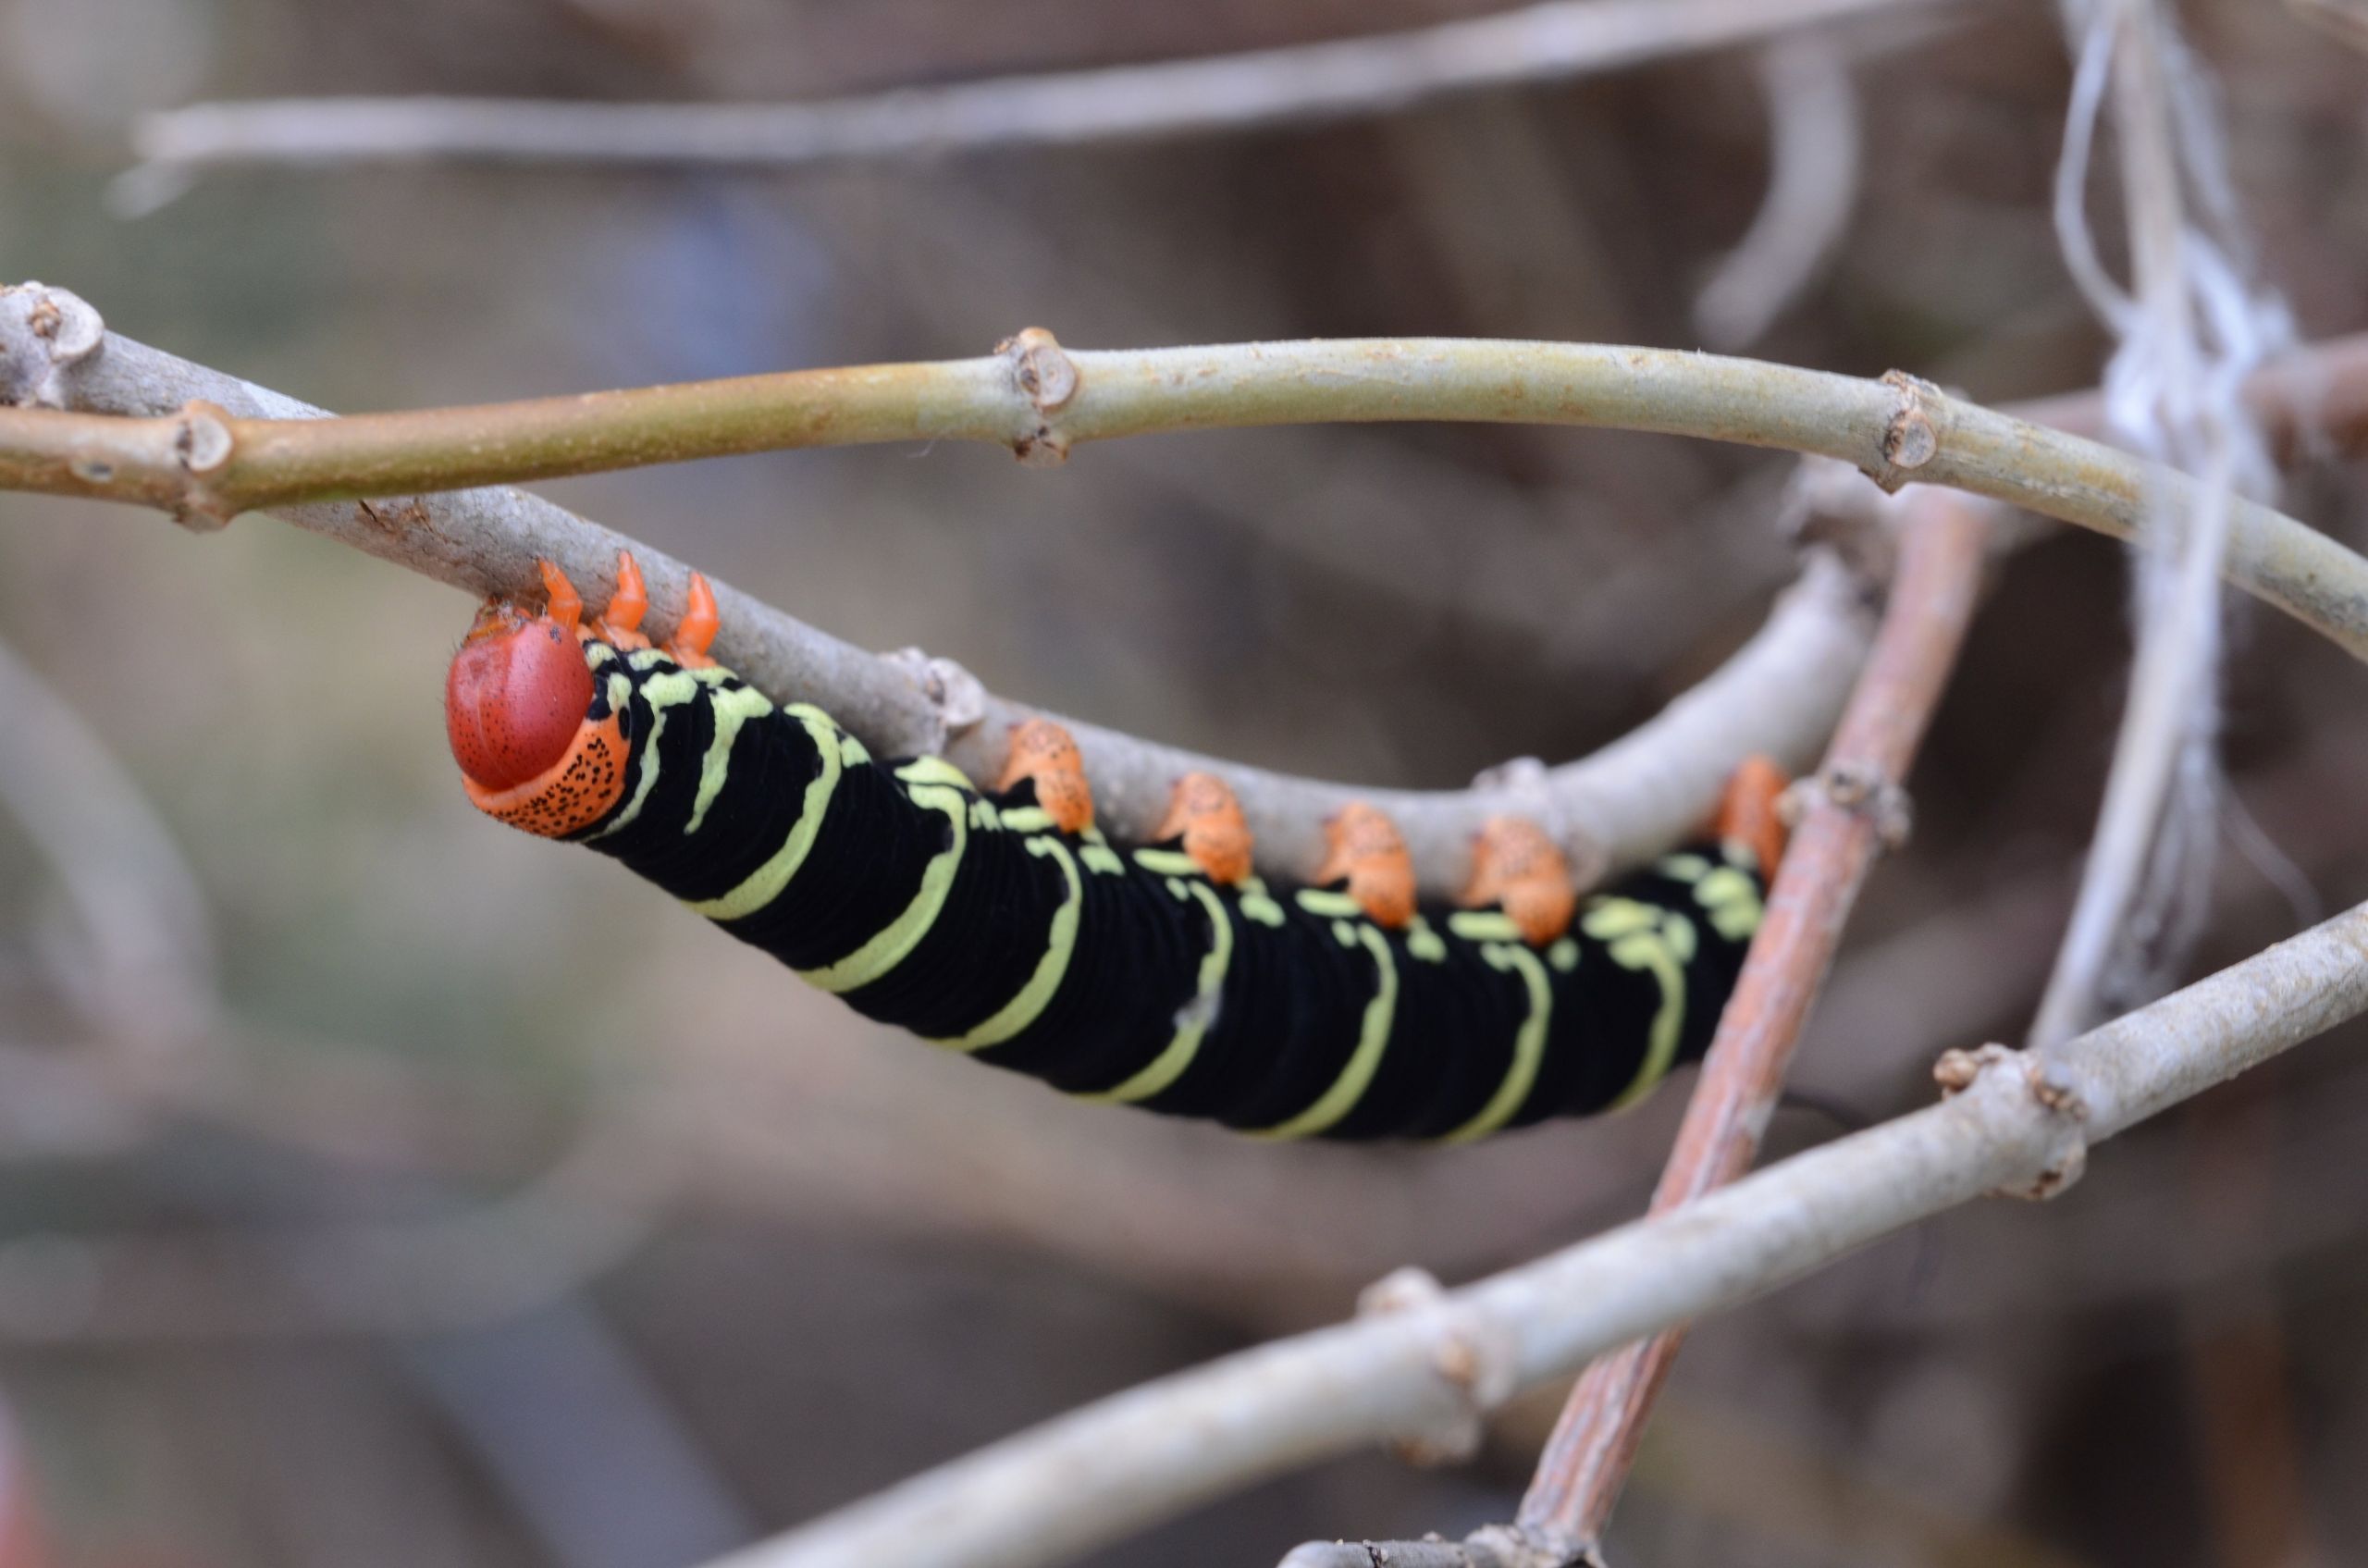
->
<box><xmin>574</xmin><ymin>642</ymin><xmax>1762</xmax><ymax>1140</ymax></box>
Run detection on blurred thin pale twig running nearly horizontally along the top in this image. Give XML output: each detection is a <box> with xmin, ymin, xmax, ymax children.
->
<box><xmin>116</xmin><ymin>0</ymin><xmax>1937</xmax><ymax>213</ymax></box>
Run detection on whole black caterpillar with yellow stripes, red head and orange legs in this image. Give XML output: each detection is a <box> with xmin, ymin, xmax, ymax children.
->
<box><xmin>445</xmin><ymin>554</ymin><xmax>1783</xmax><ymax>1142</ymax></box>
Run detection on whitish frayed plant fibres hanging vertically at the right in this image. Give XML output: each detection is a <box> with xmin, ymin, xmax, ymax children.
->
<box><xmin>2029</xmin><ymin>0</ymin><xmax>2292</xmax><ymax>1047</ymax></box>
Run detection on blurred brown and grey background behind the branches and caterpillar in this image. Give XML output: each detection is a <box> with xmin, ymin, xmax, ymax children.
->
<box><xmin>0</xmin><ymin>0</ymin><xmax>2368</xmax><ymax>1568</ymax></box>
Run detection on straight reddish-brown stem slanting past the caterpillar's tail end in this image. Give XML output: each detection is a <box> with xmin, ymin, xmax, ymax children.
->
<box><xmin>1518</xmin><ymin>490</ymin><xmax>1989</xmax><ymax>1561</ymax></box>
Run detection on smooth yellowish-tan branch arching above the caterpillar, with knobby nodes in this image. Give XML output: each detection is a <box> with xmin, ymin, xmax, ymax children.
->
<box><xmin>0</xmin><ymin>305</ymin><xmax>2368</xmax><ymax>682</ymax></box>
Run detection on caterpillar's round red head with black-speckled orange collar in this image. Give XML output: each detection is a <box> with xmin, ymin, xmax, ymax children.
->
<box><xmin>445</xmin><ymin>562</ymin><xmax>625</xmax><ymax>838</ymax></box>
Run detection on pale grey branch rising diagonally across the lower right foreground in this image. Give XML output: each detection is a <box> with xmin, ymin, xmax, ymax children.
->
<box><xmin>713</xmin><ymin>905</ymin><xmax>2368</xmax><ymax>1568</ymax></box>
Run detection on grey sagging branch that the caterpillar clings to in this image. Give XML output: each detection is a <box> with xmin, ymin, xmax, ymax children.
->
<box><xmin>0</xmin><ymin>289</ymin><xmax>1870</xmax><ymax>893</ymax></box>
